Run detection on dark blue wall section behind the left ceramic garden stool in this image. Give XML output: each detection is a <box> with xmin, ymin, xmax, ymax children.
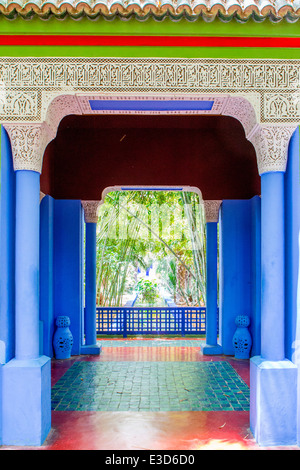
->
<box><xmin>53</xmin><ymin>200</ymin><xmax>83</xmax><ymax>355</ymax></box>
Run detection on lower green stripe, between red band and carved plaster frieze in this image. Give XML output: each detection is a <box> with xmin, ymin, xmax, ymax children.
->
<box><xmin>1</xmin><ymin>46</ymin><xmax>300</xmax><ymax>59</ymax></box>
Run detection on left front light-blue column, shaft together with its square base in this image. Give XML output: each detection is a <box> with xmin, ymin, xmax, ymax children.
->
<box><xmin>2</xmin><ymin>170</ymin><xmax>51</xmax><ymax>445</ymax></box>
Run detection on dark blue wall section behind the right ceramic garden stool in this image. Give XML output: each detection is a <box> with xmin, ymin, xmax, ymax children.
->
<box><xmin>219</xmin><ymin>197</ymin><xmax>260</xmax><ymax>355</ymax></box>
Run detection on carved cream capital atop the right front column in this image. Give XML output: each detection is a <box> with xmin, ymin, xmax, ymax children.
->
<box><xmin>248</xmin><ymin>124</ymin><xmax>296</xmax><ymax>175</ymax></box>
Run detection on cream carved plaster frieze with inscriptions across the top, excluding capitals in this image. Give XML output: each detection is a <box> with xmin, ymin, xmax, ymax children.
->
<box><xmin>0</xmin><ymin>57</ymin><xmax>300</xmax><ymax>123</ymax></box>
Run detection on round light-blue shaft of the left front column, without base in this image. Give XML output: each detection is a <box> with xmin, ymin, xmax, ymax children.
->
<box><xmin>15</xmin><ymin>170</ymin><xmax>40</xmax><ymax>359</ymax></box>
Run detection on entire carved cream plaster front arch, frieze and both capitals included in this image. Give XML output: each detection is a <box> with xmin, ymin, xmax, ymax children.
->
<box><xmin>0</xmin><ymin>58</ymin><xmax>300</xmax><ymax>176</ymax></box>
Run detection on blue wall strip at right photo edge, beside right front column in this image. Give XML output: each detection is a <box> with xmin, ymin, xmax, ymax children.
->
<box><xmin>285</xmin><ymin>128</ymin><xmax>300</xmax><ymax>362</ymax></box>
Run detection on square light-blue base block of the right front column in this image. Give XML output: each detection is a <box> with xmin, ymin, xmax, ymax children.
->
<box><xmin>250</xmin><ymin>356</ymin><xmax>297</xmax><ymax>446</ymax></box>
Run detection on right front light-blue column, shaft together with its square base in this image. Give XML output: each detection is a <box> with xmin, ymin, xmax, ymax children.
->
<box><xmin>250</xmin><ymin>171</ymin><xmax>297</xmax><ymax>446</ymax></box>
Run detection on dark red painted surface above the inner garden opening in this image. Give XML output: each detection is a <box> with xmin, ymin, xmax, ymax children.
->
<box><xmin>41</xmin><ymin>115</ymin><xmax>260</xmax><ymax>200</ymax></box>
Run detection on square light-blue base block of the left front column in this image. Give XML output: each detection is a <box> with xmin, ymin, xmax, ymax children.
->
<box><xmin>2</xmin><ymin>356</ymin><xmax>51</xmax><ymax>446</ymax></box>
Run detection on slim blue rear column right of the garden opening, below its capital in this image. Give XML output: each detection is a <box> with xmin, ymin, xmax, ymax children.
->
<box><xmin>203</xmin><ymin>222</ymin><xmax>222</xmax><ymax>354</ymax></box>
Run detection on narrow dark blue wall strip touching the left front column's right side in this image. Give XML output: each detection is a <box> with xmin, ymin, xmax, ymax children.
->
<box><xmin>40</xmin><ymin>196</ymin><xmax>54</xmax><ymax>357</ymax></box>
